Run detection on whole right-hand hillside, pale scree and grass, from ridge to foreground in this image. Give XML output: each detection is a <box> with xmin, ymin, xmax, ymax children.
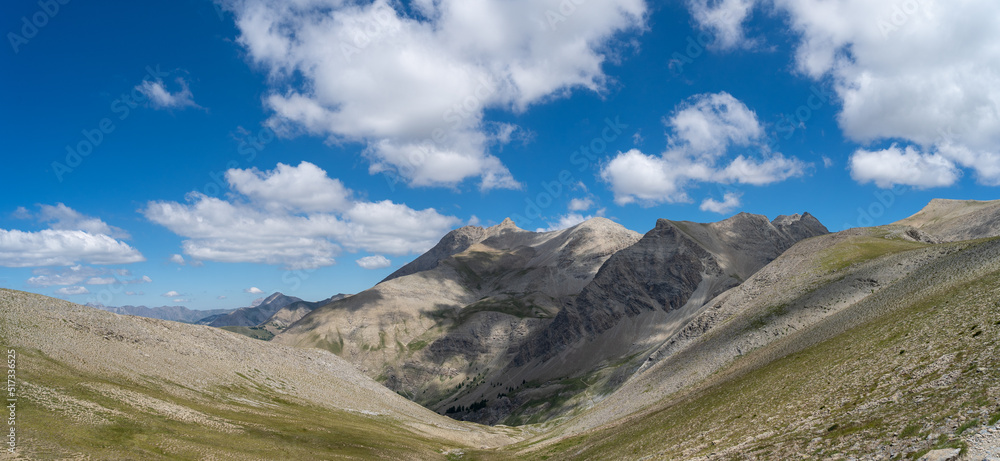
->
<box><xmin>498</xmin><ymin>203</ymin><xmax>1000</xmax><ymax>461</ymax></box>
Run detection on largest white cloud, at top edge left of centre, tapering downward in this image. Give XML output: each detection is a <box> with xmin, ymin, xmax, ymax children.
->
<box><xmin>227</xmin><ymin>0</ymin><xmax>646</xmax><ymax>189</ymax></box>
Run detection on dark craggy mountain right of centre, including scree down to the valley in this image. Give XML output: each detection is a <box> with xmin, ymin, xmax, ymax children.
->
<box><xmin>455</xmin><ymin>213</ymin><xmax>827</xmax><ymax>424</ymax></box>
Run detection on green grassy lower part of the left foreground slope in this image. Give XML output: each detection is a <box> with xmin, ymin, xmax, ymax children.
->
<box><xmin>18</xmin><ymin>351</ymin><xmax>442</xmax><ymax>459</ymax></box>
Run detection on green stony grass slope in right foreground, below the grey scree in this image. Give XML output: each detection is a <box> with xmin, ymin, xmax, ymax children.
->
<box><xmin>481</xmin><ymin>235</ymin><xmax>1000</xmax><ymax>459</ymax></box>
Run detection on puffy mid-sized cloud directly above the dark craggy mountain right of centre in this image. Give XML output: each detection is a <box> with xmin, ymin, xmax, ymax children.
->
<box><xmin>601</xmin><ymin>92</ymin><xmax>808</xmax><ymax>205</ymax></box>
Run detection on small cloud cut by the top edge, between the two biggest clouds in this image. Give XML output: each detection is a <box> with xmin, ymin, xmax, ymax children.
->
<box><xmin>688</xmin><ymin>0</ymin><xmax>756</xmax><ymax>48</ymax></box>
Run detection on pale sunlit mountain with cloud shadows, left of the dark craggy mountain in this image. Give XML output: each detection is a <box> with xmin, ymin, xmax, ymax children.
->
<box><xmin>273</xmin><ymin>218</ymin><xmax>639</xmax><ymax>411</ymax></box>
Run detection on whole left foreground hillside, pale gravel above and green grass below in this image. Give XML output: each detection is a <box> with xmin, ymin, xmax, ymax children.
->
<box><xmin>0</xmin><ymin>289</ymin><xmax>513</xmax><ymax>459</ymax></box>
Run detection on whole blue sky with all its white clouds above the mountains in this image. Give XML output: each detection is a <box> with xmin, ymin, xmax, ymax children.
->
<box><xmin>0</xmin><ymin>0</ymin><xmax>1000</xmax><ymax>308</ymax></box>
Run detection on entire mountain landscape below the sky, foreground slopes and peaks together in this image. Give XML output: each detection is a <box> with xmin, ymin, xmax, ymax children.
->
<box><xmin>7</xmin><ymin>200</ymin><xmax>1000</xmax><ymax>460</ymax></box>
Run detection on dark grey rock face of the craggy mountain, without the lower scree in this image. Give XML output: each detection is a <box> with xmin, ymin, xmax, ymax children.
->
<box><xmin>512</xmin><ymin>213</ymin><xmax>828</xmax><ymax>372</ymax></box>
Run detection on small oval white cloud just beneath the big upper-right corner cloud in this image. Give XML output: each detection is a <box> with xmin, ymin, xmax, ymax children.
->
<box><xmin>850</xmin><ymin>144</ymin><xmax>961</xmax><ymax>189</ymax></box>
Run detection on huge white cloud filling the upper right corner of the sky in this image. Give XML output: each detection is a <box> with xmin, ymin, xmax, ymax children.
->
<box><xmin>692</xmin><ymin>0</ymin><xmax>1000</xmax><ymax>187</ymax></box>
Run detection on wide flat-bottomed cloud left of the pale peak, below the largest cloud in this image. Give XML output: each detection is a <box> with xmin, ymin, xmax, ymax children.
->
<box><xmin>142</xmin><ymin>162</ymin><xmax>461</xmax><ymax>269</ymax></box>
